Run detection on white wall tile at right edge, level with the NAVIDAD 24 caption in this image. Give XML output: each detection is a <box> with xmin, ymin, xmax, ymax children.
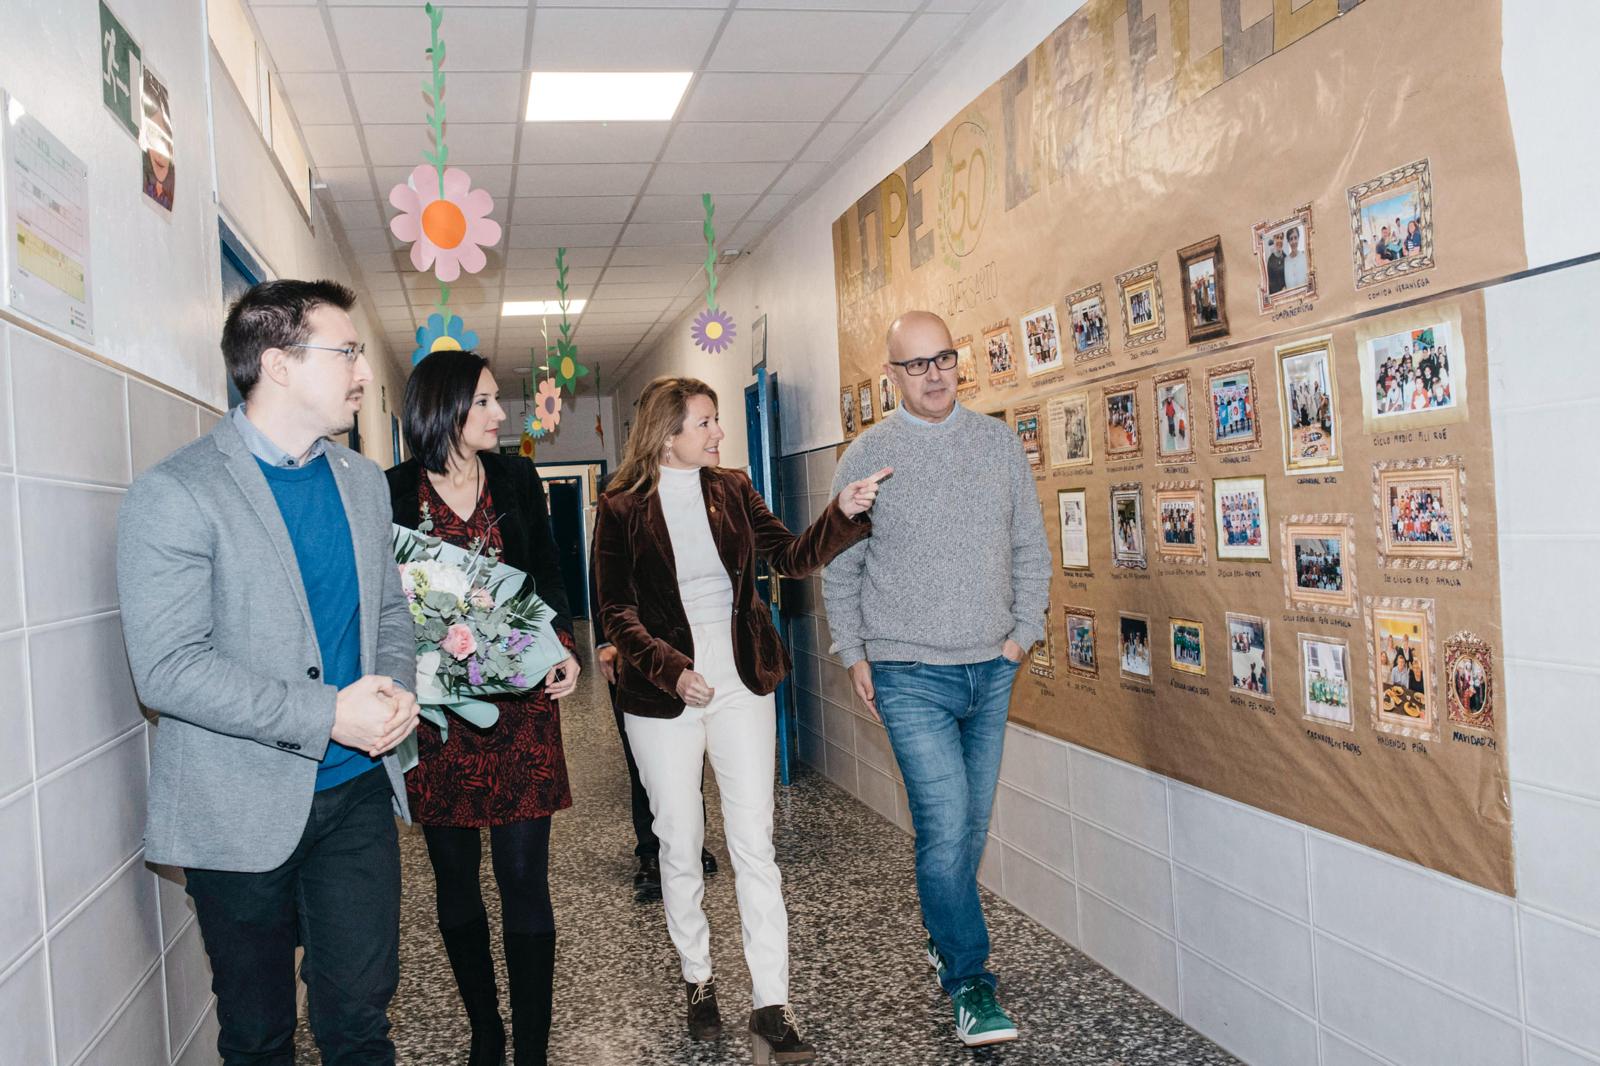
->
<box><xmin>1502</xmin><ymin>661</ymin><xmax>1600</xmax><ymax>800</ymax></box>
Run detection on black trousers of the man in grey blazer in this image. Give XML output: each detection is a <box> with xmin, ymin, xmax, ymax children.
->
<box><xmin>184</xmin><ymin>768</ymin><xmax>400</xmax><ymax>1066</ymax></box>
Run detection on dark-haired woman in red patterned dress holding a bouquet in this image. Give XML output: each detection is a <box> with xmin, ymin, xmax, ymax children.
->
<box><xmin>389</xmin><ymin>352</ymin><xmax>579</xmax><ymax>1066</ymax></box>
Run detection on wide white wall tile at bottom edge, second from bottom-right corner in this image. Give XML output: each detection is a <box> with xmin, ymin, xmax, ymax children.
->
<box><xmin>1317</xmin><ymin>935</ymin><xmax>1522</xmax><ymax>1066</ymax></box>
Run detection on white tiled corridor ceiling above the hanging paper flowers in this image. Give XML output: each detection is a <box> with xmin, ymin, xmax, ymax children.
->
<box><xmin>250</xmin><ymin>0</ymin><xmax>994</xmax><ymax>379</ymax></box>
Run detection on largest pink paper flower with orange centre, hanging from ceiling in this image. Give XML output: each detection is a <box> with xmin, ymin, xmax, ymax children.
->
<box><xmin>389</xmin><ymin>165</ymin><xmax>501</xmax><ymax>282</ymax></box>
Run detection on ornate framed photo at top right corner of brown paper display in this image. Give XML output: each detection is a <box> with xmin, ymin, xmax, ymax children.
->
<box><xmin>1346</xmin><ymin>158</ymin><xmax>1434</xmax><ymax>290</ymax></box>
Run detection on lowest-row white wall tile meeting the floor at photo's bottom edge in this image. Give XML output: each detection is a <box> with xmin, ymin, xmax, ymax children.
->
<box><xmin>1178</xmin><ymin>948</ymin><xmax>1318</xmax><ymax>1066</ymax></box>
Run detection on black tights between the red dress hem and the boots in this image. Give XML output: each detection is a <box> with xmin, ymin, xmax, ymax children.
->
<box><xmin>422</xmin><ymin>816</ymin><xmax>555</xmax><ymax>933</ymax></box>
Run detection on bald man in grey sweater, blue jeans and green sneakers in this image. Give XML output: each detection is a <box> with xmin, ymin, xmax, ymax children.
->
<box><xmin>822</xmin><ymin>311</ymin><xmax>1051</xmax><ymax>1047</ymax></box>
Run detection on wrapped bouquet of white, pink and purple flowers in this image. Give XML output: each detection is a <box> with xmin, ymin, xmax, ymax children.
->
<box><xmin>394</xmin><ymin>525</ymin><xmax>566</xmax><ymax>770</ymax></box>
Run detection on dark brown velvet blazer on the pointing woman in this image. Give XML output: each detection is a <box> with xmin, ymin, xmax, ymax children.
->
<box><xmin>595</xmin><ymin>467</ymin><xmax>872</xmax><ymax>719</ymax></box>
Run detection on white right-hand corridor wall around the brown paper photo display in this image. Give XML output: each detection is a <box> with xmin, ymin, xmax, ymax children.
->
<box><xmin>619</xmin><ymin>0</ymin><xmax>1600</xmax><ymax>1066</ymax></box>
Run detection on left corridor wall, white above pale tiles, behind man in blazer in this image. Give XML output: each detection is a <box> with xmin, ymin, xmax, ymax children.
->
<box><xmin>0</xmin><ymin>0</ymin><xmax>405</xmax><ymax>1066</ymax></box>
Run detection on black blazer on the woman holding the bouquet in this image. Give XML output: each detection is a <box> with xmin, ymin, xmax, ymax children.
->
<box><xmin>386</xmin><ymin>451</ymin><xmax>573</xmax><ymax>637</ymax></box>
